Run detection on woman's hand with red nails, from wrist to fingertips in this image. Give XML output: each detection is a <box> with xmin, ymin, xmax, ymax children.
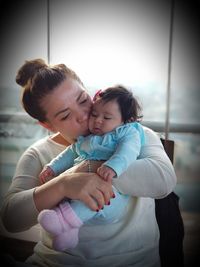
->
<box><xmin>60</xmin><ymin>173</ymin><xmax>114</xmax><ymax>211</ymax></box>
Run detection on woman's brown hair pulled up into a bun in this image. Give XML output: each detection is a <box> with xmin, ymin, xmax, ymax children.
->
<box><xmin>16</xmin><ymin>59</ymin><xmax>83</xmax><ymax>122</ymax></box>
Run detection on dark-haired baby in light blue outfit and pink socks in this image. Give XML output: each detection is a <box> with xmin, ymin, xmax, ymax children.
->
<box><xmin>38</xmin><ymin>86</ymin><xmax>145</xmax><ymax>251</ymax></box>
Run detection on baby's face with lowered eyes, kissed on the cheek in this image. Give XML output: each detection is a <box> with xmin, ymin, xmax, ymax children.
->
<box><xmin>89</xmin><ymin>100</ymin><xmax>123</xmax><ymax>135</ymax></box>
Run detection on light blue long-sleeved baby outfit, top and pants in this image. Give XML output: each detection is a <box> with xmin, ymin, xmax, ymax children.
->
<box><xmin>47</xmin><ymin>122</ymin><xmax>145</xmax><ymax>223</ymax></box>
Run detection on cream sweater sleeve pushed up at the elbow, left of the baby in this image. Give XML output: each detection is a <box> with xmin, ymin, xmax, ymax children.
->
<box><xmin>1</xmin><ymin>142</ymin><xmax>52</xmax><ymax>233</ymax></box>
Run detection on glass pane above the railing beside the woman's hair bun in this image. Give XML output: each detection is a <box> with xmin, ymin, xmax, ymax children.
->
<box><xmin>0</xmin><ymin>0</ymin><xmax>47</xmax><ymax>112</ymax></box>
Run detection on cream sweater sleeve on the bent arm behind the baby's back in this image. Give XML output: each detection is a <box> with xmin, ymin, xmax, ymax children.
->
<box><xmin>113</xmin><ymin>127</ymin><xmax>176</xmax><ymax>198</ymax></box>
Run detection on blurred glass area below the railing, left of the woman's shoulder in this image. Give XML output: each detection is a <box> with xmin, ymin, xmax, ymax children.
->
<box><xmin>0</xmin><ymin>114</ymin><xmax>47</xmax><ymax>202</ymax></box>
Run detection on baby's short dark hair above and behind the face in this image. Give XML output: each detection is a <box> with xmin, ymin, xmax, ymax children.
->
<box><xmin>94</xmin><ymin>85</ymin><xmax>142</xmax><ymax>123</ymax></box>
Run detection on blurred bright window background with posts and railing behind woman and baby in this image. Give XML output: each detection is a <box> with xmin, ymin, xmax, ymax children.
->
<box><xmin>0</xmin><ymin>0</ymin><xmax>200</xmax><ymax>266</ymax></box>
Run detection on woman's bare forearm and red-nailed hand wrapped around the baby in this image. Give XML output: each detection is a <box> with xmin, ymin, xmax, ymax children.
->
<box><xmin>34</xmin><ymin>172</ymin><xmax>114</xmax><ymax>214</ymax></box>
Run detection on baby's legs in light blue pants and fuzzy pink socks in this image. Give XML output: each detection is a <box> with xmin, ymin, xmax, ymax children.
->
<box><xmin>38</xmin><ymin>189</ymin><xmax>130</xmax><ymax>251</ymax></box>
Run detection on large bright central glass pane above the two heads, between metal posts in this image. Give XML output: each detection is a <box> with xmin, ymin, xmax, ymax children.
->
<box><xmin>50</xmin><ymin>0</ymin><xmax>170</xmax><ymax>121</ymax></box>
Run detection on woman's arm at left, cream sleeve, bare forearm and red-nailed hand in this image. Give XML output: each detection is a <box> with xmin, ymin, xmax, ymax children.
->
<box><xmin>1</xmin><ymin>149</ymin><xmax>112</xmax><ymax>232</ymax></box>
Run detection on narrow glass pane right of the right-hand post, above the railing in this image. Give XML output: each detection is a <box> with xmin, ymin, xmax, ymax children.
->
<box><xmin>171</xmin><ymin>1</ymin><xmax>200</xmax><ymax>124</ymax></box>
